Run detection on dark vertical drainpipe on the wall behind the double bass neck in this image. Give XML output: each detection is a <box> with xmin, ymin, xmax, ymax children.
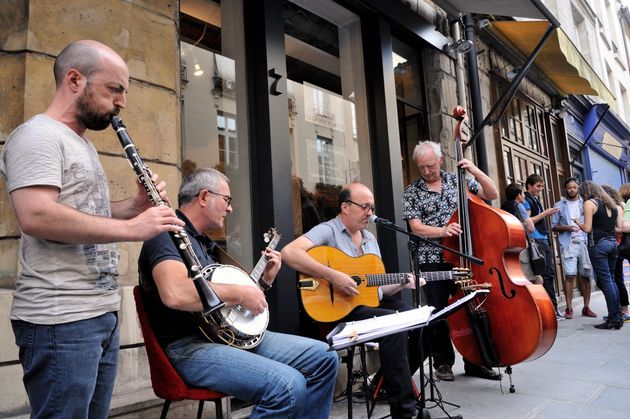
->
<box><xmin>464</xmin><ymin>14</ymin><xmax>489</xmax><ymax>174</ymax></box>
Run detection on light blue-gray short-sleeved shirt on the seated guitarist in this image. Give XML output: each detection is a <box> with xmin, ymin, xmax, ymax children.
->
<box><xmin>304</xmin><ymin>217</ymin><xmax>381</xmax><ymax>257</ymax></box>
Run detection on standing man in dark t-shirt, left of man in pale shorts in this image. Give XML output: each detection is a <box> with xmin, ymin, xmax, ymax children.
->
<box><xmin>523</xmin><ymin>174</ymin><xmax>564</xmax><ymax>320</ymax></box>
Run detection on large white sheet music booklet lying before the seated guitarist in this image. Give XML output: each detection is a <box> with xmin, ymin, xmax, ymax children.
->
<box><xmin>326</xmin><ymin>306</ymin><xmax>433</xmax><ymax>345</ymax></box>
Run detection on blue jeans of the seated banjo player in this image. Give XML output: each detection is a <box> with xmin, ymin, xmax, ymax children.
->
<box><xmin>165</xmin><ymin>331</ymin><xmax>339</xmax><ymax>419</ymax></box>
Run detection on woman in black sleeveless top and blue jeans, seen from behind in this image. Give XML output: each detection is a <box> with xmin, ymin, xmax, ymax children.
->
<box><xmin>573</xmin><ymin>180</ymin><xmax>623</xmax><ymax>330</ymax></box>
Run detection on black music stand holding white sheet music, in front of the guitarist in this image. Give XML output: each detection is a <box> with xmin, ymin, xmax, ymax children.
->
<box><xmin>326</xmin><ymin>290</ymin><xmax>490</xmax><ymax>419</ymax></box>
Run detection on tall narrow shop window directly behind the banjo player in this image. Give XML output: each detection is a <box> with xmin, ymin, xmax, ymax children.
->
<box><xmin>179</xmin><ymin>0</ymin><xmax>253</xmax><ymax>265</ymax></box>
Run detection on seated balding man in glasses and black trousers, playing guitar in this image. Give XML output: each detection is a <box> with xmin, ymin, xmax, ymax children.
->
<box><xmin>282</xmin><ymin>183</ymin><xmax>424</xmax><ymax>418</ymax></box>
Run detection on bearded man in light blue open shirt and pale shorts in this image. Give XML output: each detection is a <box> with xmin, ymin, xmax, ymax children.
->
<box><xmin>551</xmin><ymin>178</ymin><xmax>597</xmax><ymax>319</ymax></box>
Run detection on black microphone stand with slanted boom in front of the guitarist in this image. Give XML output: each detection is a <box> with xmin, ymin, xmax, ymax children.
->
<box><xmin>371</xmin><ymin>217</ymin><xmax>484</xmax><ymax>419</ymax></box>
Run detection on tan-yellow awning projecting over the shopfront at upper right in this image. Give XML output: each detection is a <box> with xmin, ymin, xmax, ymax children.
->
<box><xmin>491</xmin><ymin>21</ymin><xmax>617</xmax><ymax>111</ymax></box>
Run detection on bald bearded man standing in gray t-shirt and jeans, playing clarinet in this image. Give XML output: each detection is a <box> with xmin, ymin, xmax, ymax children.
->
<box><xmin>0</xmin><ymin>40</ymin><xmax>184</xmax><ymax>419</ymax></box>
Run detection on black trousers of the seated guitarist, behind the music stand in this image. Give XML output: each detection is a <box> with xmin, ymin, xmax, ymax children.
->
<box><xmin>343</xmin><ymin>297</ymin><xmax>419</xmax><ymax>418</ymax></box>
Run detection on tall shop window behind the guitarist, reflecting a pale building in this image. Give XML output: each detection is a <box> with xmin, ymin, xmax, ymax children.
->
<box><xmin>283</xmin><ymin>0</ymin><xmax>372</xmax><ymax>235</ymax></box>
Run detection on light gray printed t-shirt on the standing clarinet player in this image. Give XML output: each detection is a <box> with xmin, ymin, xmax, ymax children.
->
<box><xmin>0</xmin><ymin>114</ymin><xmax>120</xmax><ymax>324</ymax></box>
